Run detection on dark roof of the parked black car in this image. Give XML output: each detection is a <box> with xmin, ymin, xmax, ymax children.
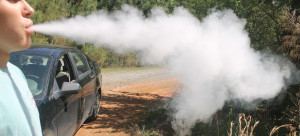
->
<box><xmin>12</xmin><ymin>44</ymin><xmax>77</xmax><ymax>56</ymax></box>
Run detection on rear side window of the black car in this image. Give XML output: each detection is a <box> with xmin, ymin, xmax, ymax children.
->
<box><xmin>71</xmin><ymin>52</ymin><xmax>89</xmax><ymax>76</ymax></box>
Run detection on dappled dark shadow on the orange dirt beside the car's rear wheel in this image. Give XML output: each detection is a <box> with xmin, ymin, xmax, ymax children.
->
<box><xmin>77</xmin><ymin>91</ymin><xmax>164</xmax><ymax>135</ymax></box>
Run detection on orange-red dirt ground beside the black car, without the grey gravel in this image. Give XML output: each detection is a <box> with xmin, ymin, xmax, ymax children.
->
<box><xmin>76</xmin><ymin>79</ymin><xmax>180</xmax><ymax>136</ymax></box>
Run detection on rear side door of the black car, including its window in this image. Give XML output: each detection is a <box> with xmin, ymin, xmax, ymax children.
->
<box><xmin>70</xmin><ymin>52</ymin><xmax>96</xmax><ymax>123</ymax></box>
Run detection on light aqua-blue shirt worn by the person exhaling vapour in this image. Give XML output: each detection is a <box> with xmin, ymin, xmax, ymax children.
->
<box><xmin>0</xmin><ymin>63</ymin><xmax>42</xmax><ymax>136</ymax></box>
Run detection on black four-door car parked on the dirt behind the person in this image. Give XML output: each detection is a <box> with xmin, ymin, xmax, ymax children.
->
<box><xmin>10</xmin><ymin>45</ymin><xmax>102</xmax><ymax>136</ymax></box>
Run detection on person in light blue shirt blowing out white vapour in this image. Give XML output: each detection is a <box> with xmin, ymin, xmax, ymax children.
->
<box><xmin>0</xmin><ymin>0</ymin><xmax>42</xmax><ymax>136</ymax></box>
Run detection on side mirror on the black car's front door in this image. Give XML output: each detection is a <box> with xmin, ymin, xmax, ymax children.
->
<box><xmin>61</xmin><ymin>82</ymin><xmax>81</xmax><ymax>95</ymax></box>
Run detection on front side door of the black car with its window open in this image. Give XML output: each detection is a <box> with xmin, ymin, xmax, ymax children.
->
<box><xmin>53</xmin><ymin>54</ymin><xmax>81</xmax><ymax>136</ymax></box>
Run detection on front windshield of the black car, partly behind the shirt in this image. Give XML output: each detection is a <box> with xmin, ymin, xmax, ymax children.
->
<box><xmin>9</xmin><ymin>53</ymin><xmax>51</xmax><ymax>100</ymax></box>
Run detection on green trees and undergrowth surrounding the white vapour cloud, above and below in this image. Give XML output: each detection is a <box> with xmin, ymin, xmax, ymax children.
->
<box><xmin>27</xmin><ymin>0</ymin><xmax>300</xmax><ymax>136</ymax></box>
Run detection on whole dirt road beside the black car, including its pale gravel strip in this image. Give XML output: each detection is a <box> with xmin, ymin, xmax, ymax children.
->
<box><xmin>76</xmin><ymin>68</ymin><xmax>179</xmax><ymax>136</ymax></box>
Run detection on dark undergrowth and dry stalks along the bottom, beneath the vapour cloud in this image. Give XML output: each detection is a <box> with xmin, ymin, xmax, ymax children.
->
<box><xmin>129</xmin><ymin>94</ymin><xmax>300</xmax><ymax>136</ymax></box>
